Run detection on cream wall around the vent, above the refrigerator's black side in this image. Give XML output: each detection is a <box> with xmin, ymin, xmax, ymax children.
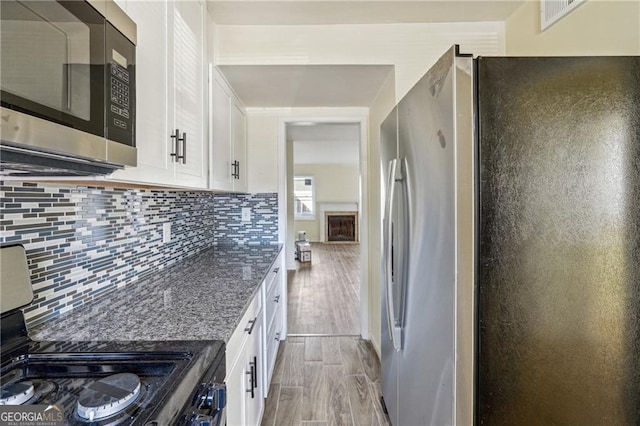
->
<box><xmin>506</xmin><ymin>0</ymin><xmax>640</xmax><ymax>56</ymax></box>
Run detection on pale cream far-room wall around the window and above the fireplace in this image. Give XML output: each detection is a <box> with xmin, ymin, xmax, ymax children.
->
<box><xmin>293</xmin><ymin>163</ymin><xmax>360</xmax><ymax>241</ymax></box>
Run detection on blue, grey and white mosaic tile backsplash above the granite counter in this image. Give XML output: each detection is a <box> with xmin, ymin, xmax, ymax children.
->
<box><xmin>0</xmin><ymin>181</ymin><xmax>278</xmax><ymax>326</ymax></box>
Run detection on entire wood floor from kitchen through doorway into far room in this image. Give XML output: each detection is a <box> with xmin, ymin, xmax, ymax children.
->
<box><xmin>262</xmin><ymin>243</ymin><xmax>389</xmax><ymax>426</ymax></box>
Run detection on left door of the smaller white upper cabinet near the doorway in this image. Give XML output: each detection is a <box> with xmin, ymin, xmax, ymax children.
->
<box><xmin>211</xmin><ymin>75</ymin><xmax>233</xmax><ymax>191</ymax></box>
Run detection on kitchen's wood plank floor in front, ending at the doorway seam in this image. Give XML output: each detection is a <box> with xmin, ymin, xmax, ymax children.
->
<box><xmin>262</xmin><ymin>336</ymin><xmax>389</xmax><ymax>426</ymax></box>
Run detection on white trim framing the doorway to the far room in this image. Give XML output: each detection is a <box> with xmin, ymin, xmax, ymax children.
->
<box><xmin>278</xmin><ymin>112</ymin><xmax>370</xmax><ymax>340</ymax></box>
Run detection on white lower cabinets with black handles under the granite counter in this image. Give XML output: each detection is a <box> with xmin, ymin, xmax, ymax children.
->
<box><xmin>225</xmin><ymin>254</ymin><xmax>286</xmax><ymax>426</ymax></box>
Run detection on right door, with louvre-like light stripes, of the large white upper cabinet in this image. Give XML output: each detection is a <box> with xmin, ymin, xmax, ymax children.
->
<box><xmin>172</xmin><ymin>0</ymin><xmax>207</xmax><ymax>187</ymax></box>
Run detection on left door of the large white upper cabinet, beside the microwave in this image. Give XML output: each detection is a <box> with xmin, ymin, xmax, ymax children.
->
<box><xmin>111</xmin><ymin>1</ymin><xmax>173</xmax><ymax>183</ymax></box>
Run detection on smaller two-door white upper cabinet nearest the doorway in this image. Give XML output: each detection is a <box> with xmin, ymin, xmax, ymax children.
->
<box><xmin>210</xmin><ymin>67</ymin><xmax>247</xmax><ymax>192</ymax></box>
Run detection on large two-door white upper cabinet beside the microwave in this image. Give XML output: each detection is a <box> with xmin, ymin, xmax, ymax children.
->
<box><xmin>111</xmin><ymin>0</ymin><xmax>208</xmax><ymax>188</ymax></box>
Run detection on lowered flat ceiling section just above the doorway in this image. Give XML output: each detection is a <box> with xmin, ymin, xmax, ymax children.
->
<box><xmin>219</xmin><ymin>65</ymin><xmax>393</xmax><ymax>108</ymax></box>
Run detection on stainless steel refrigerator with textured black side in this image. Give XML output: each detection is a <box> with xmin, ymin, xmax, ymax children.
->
<box><xmin>381</xmin><ymin>46</ymin><xmax>640</xmax><ymax>426</ymax></box>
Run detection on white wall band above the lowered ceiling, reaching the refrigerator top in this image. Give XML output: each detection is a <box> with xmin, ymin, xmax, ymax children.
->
<box><xmin>216</xmin><ymin>22</ymin><xmax>504</xmax><ymax>100</ymax></box>
